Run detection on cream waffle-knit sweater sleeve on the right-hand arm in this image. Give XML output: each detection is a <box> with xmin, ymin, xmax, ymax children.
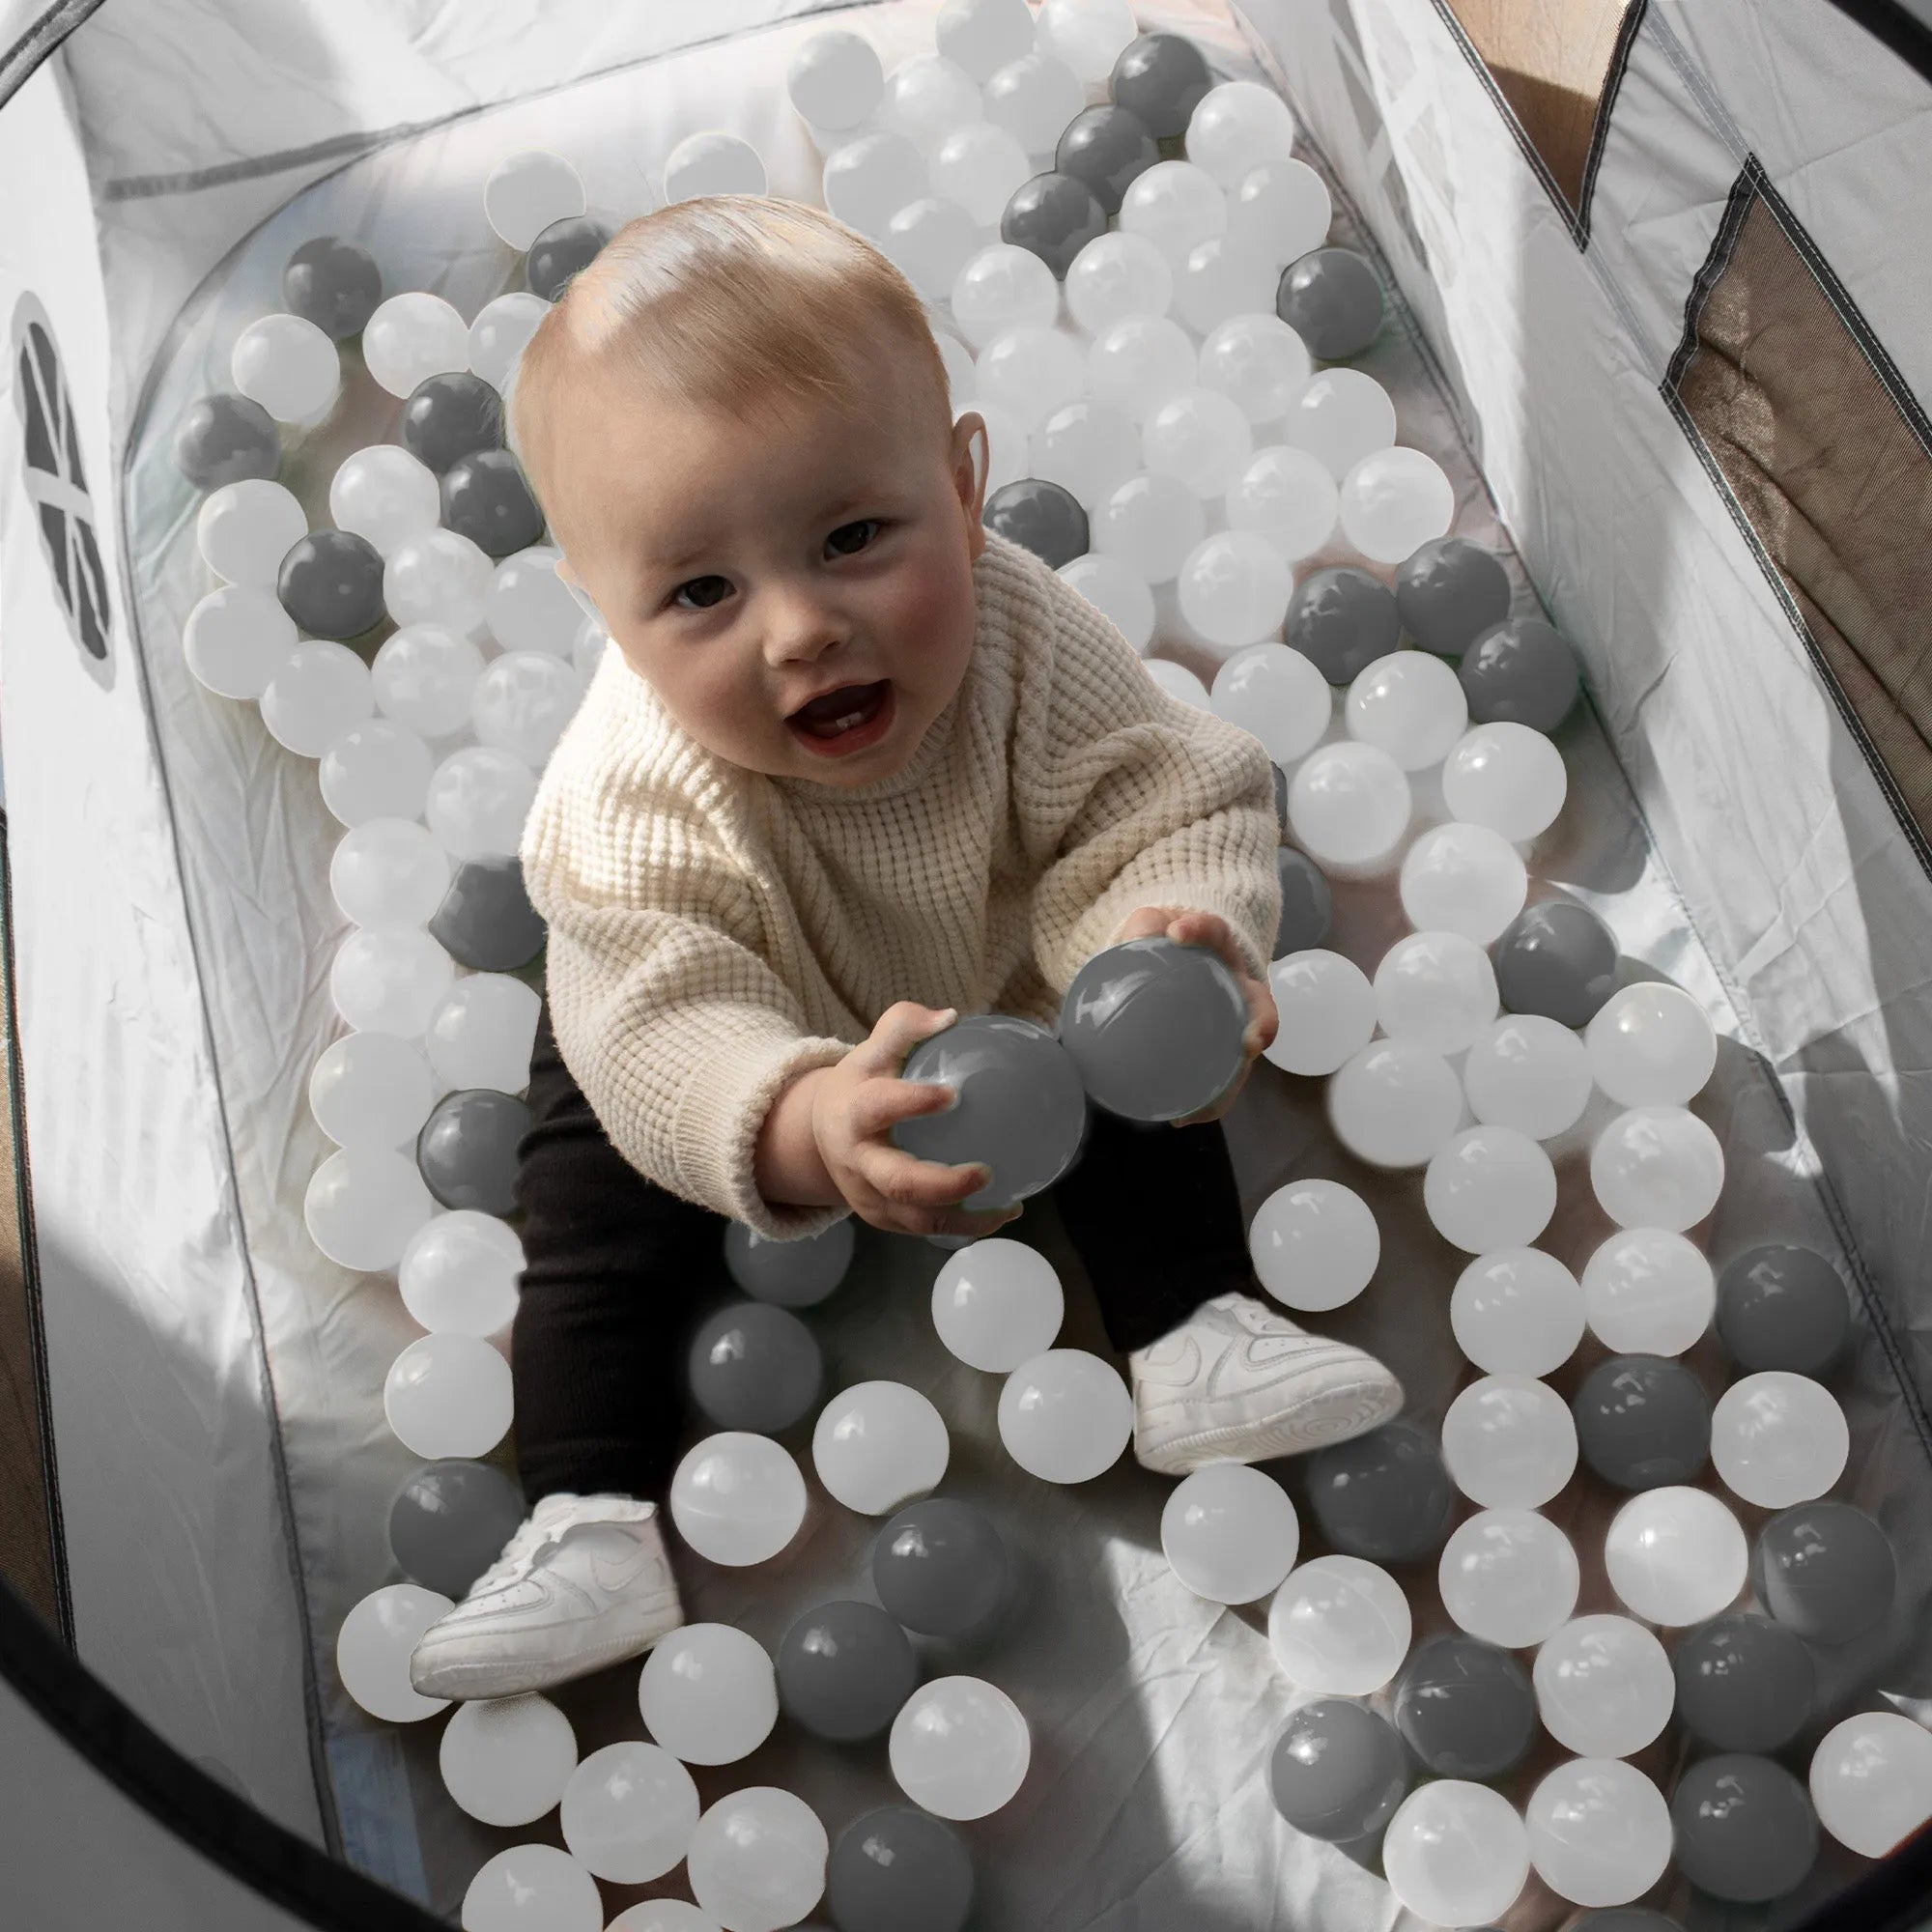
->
<box><xmin>1014</xmin><ymin>599</ymin><xmax>1281</xmax><ymax>993</ymax></box>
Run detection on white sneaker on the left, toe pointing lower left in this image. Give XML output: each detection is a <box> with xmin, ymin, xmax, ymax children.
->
<box><xmin>410</xmin><ymin>1492</ymin><xmax>684</xmax><ymax>1698</ymax></box>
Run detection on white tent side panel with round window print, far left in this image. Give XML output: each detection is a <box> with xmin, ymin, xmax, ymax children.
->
<box><xmin>0</xmin><ymin>62</ymin><xmax>321</xmax><ymax>1835</ymax></box>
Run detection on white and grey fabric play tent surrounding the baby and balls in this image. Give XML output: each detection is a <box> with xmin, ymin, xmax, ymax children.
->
<box><xmin>0</xmin><ymin>0</ymin><xmax>1932</xmax><ymax>1932</ymax></box>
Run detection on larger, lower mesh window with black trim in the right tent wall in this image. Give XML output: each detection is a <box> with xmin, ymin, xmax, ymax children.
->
<box><xmin>1663</xmin><ymin>158</ymin><xmax>1932</xmax><ymax>858</ymax></box>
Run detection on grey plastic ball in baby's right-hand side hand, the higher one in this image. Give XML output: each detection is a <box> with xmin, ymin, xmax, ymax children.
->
<box><xmin>1066</xmin><ymin>933</ymin><xmax>1248</xmax><ymax>1121</ymax></box>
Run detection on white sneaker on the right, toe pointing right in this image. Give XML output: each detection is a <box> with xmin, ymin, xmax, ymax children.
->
<box><xmin>1126</xmin><ymin>1294</ymin><xmax>1403</xmax><ymax>1476</ymax></box>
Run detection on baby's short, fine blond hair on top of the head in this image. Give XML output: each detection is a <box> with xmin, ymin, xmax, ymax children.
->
<box><xmin>504</xmin><ymin>195</ymin><xmax>952</xmax><ymax>554</ymax></box>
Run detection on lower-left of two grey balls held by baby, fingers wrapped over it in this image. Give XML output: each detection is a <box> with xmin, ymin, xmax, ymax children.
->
<box><xmin>889</xmin><ymin>1012</ymin><xmax>1088</xmax><ymax>1213</ymax></box>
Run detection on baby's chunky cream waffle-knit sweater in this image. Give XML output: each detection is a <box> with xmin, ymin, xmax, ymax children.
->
<box><xmin>520</xmin><ymin>531</ymin><xmax>1281</xmax><ymax>1240</ymax></box>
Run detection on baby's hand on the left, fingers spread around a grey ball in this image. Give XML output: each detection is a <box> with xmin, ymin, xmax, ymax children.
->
<box><xmin>811</xmin><ymin>999</ymin><xmax>1020</xmax><ymax>1236</ymax></box>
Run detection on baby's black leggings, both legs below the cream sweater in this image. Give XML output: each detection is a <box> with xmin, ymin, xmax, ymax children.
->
<box><xmin>510</xmin><ymin>1003</ymin><xmax>1256</xmax><ymax>1503</ymax></box>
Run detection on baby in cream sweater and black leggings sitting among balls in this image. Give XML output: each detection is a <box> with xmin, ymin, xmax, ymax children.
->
<box><xmin>412</xmin><ymin>195</ymin><xmax>1403</xmax><ymax>1698</ymax></box>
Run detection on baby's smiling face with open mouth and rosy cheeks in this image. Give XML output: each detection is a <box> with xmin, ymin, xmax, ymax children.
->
<box><xmin>564</xmin><ymin>340</ymin><xmax>985</xmax><ymax>786</ymax></box>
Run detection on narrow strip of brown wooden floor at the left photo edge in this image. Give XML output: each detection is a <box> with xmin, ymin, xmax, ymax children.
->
<box><xmin>0</xmin><ymin>817</ymin><xmax>60</xmax><ymax>1629</ymax></box>
